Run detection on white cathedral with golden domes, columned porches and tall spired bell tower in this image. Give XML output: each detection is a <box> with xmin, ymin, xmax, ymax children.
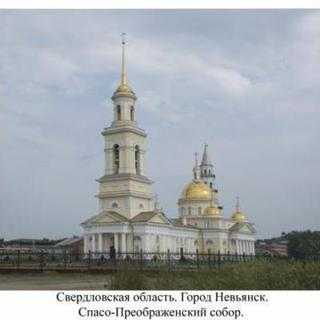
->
<box><xmin>81</xmin><ymin>41</ymin><xmax>256</xmax><ymax>254</ymax></box>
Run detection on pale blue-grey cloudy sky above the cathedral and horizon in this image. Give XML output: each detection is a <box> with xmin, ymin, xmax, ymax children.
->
<box><xmin>0</xmin><ymin>10</ymin><xmax>320</xmax><ymax>239</ymax></box>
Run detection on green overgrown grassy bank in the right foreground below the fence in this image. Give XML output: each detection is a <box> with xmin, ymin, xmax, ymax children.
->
<box><xmin>110</xmin><ymin>260</ymin><xmax>320</xmax><ymax>290</ymax></box>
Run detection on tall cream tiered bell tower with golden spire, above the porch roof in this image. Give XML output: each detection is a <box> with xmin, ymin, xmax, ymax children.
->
<box><xmin>97</xmin><ymin>34</ymin><xmax>154</xmax><ymax>218</ymax></box>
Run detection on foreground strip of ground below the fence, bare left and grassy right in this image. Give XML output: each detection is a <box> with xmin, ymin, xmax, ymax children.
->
<box><xmin>0</xmin><ymin>260</ymin><xmax>320</xmax><ymax>290</ymax></box>
